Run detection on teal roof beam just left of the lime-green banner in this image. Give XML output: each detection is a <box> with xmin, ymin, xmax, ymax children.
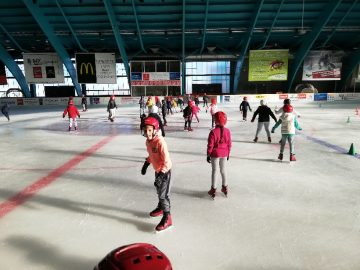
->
<box><xmin>233</xmin><ymin>0</ymin><xmax>264</xmax><ymax>93</ymax></box>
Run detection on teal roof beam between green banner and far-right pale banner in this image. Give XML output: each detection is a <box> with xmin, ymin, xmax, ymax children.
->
<box><xmin>286</xmin><ymin>0</ymin><xmax>342</xmax><ymax>92</ymax></box>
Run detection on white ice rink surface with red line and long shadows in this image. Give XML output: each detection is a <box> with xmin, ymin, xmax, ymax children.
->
<box><xmin>0</xmin><ymin>101</ymin><xmax>360</xmax><ymax>270</ymax></box>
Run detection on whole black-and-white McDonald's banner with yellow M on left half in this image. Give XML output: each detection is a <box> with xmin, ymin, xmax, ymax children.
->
<box><xmin>75</xmin><ymin>53</ymin><xmax>116</xmax><ymax>84</ymax></box>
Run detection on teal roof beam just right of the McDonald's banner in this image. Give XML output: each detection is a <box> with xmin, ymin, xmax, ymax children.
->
<box><xmin>103</xmin><ymin>0</ymin><xmax>131</xmax><ymax>87</ymax></box>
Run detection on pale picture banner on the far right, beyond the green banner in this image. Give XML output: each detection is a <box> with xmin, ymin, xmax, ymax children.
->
<box><xmin>302</xmin><ymin>51</ymin><xmax>344</xmax><ymax>81</ymax></box>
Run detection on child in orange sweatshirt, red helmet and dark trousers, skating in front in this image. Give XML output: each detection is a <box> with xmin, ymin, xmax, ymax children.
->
<box><xmin>141</xmin><ymin>117</ymin><xmax>172</xmax><ymax>231</ymax></box>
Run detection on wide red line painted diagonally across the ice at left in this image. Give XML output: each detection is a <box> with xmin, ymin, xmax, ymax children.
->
<box><xmin>0</xmin><ymin>135</ymin><xmax>115</xmax><ymax>218</ymax></box>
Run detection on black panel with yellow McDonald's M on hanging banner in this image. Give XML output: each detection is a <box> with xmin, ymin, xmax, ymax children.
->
<box><xmin>75</xmin><ymin>53</ymin><xmax>96</xmax><ymax>83</ymax></box>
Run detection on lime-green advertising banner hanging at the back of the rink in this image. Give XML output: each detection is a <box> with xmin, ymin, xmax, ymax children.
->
<box><xmin>249</xmin><ymin>50</ymin><xmax>289</xmax><ymax>82</ymax></box>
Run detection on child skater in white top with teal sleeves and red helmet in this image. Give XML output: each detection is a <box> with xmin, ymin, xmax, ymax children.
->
<box><xmin>271</xmin><ymin>104</ymin><xmax>302</xmax><ymax>161</ymax></box>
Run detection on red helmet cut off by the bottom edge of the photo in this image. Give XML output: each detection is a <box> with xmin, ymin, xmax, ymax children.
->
<box><xmin>94</xmin><ymin>243</ymin><xmax>172</xmax><ymax>270</ymax></box>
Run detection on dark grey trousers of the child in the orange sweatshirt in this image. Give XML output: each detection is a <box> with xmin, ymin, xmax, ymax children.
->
<box><xmin>154</xmin><ymin>170</ymin><xmax>171</xmax><ymax>213</ymax></box>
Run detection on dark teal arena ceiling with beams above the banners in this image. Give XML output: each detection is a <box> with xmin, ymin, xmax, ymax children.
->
<box><xmin>0</xmin><ymin>0</ymin><xmax>360</xmax><ymax>60</ymax></box>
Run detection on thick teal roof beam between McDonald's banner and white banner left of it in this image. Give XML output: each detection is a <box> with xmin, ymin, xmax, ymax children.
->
<box><xmin>22</xmin><ymin>0</ymin><xmax>82</xmax><ymax>96</ymax></box>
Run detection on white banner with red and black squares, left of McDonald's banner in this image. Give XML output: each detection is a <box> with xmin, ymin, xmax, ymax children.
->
<box><xmin>23</xmin><ymin>53</ymin><xmax>64</xmax><ymax>83</ymax></box>
